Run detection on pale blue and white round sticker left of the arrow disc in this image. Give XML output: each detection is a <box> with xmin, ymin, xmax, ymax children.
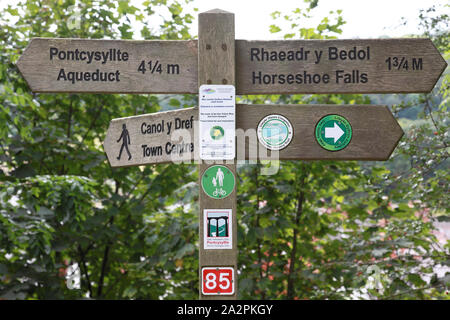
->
<box><xmin>258</xmin><ymin>114</ymin><xmax>294</xmax><ymax>150</ymax></box>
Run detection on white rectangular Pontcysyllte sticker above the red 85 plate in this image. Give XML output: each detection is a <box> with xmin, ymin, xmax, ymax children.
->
<box><xmin>203</xmin><ymin>209</ymin><xmax>233</xmax><ymax>249</ymax></box>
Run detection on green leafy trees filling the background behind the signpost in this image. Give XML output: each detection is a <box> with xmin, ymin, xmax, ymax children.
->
<box><xmin>0</xmin><ymin>0</ymin><xmax>450</xmax><ymax>299</ymax></box>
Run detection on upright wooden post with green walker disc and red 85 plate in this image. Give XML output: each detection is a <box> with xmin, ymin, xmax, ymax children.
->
<box><xmin>198</xmin><ymin>10</ymin><xmax>238</xmax><ymax>300</ymax></box>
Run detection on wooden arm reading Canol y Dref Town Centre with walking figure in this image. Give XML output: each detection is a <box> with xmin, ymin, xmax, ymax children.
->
<box><xmin>103</xmin><ymin>108</ymin><xmax>198</xmax><ymax>167</ymax></box>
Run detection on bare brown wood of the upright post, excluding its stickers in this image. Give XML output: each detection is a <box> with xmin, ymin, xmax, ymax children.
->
<box><xmin>196</xmin><ymin>9</ymin><xmax>239</xmax><ymax>300</ymax></box>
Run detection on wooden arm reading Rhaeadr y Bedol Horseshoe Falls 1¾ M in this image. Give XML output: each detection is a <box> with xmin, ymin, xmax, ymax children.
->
<box><xmin>236</xmin><ymin>39</ymin><xmax>447</xmax><ymax>94</ymax></box>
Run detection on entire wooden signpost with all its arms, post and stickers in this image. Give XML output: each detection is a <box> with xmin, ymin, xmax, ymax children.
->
<box><xmin>17</xmin><ymin>10</ymin><xmax>447</xmax><ymax>299</ymax></box>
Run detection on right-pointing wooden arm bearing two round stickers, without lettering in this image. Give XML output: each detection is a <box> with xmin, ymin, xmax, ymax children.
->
<box><xmin>236</xmin><ymin>105</ymin><xmax>403</xmax><ymax>160</ymax></box>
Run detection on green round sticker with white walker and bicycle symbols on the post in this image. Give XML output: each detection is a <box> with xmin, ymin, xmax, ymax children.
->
<box><xmin>202</xmin><ymin>165</ymin><xmax>236</xmax><ymax>199</ymax></box>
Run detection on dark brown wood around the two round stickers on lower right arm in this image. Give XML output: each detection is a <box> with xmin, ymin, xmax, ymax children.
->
<box><xmin>236</xmin><ymin>105</ymin><xmax>403</xmax><ymax>160</ymax></box>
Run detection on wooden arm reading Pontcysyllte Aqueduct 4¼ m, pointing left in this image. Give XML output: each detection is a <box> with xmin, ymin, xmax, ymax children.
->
<box><xmin>17</xmin><ymin>38</ymin><xmax>198</xmax><ymax>93</ymax></box>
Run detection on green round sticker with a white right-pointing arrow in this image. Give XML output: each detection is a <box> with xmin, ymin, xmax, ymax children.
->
<box><xmin>316</xmin><ymin>114</ymin><xmax>352</xmax><ymax>151</ymax></box>
